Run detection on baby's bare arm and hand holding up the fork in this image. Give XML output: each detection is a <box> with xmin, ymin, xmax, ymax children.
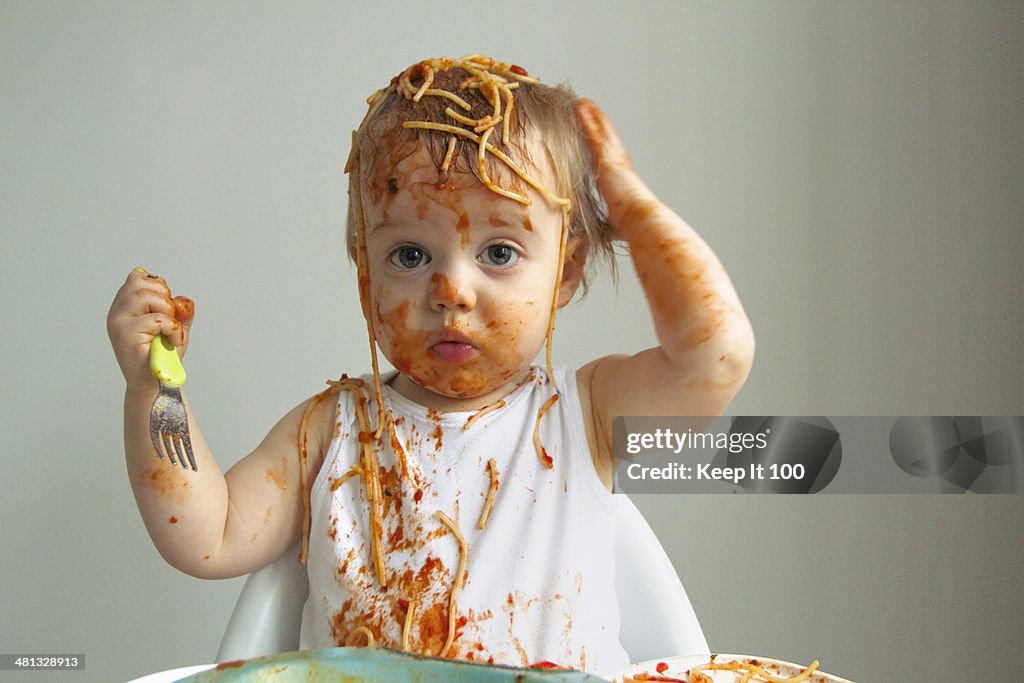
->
<box><xmin>106</xmin><ymin>270</ymin><xmax>333</xmax><ymax>579</ymax></box>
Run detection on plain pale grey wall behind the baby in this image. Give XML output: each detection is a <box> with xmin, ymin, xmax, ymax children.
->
<box><xmin>0</xmin><ymin>1</ymin><xmax>1024</xmax><ymax>681</ymax></box>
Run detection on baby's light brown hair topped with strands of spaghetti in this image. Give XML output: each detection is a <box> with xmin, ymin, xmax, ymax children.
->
<box><xmin>345</xmin><ymin>55</ymin><xmax>615</xmax><ymax>292</ymax></box>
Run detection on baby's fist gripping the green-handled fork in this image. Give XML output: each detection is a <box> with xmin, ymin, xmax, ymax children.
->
<box><xmin>106</xmin><ymin>268</ymin><xmax>196</xmax><ymax>384</ymax></box>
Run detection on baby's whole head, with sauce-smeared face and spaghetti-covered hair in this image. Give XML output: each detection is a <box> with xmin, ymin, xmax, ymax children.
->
<box><xmin>346</xmin><ymin>56</ymin><xmax>612</xmax><ymax>397</ymax></box>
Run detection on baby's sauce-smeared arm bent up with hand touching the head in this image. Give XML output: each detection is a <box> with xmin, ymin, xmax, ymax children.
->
<box><xmin>578</xmin><ymin>100</ymin><xmax>754</xmax><ymax>471</ymax></box>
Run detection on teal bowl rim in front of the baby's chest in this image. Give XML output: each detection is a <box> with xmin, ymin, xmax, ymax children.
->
<box><xmin>182</xmin><ymin>647</ymin><xmax>606</xmax><ymax>683</ymax></box>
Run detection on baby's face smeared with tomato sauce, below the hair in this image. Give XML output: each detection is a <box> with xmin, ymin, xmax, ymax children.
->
<box><xmin>362</xmin><ymin>140</ymin><xmax>571</xmax><ymax>404</ymax></box>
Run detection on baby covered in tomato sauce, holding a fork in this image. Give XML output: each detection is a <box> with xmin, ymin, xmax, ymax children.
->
<box><xmin>108</xmin><ymin>55</ymin><xmax>754</xmax><ymax>672</ymax></box>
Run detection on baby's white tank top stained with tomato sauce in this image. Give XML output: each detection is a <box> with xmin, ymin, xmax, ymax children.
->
<box><xmin>300</xmin><ymin>368</ymin><xmax>629</xmax><ymax>674</ymax></box>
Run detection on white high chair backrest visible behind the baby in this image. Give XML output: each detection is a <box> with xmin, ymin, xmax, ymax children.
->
<box><xmin>217</xmin><ymin>495</ymin><xmax>709</xmax><ymax>663</ymax></box>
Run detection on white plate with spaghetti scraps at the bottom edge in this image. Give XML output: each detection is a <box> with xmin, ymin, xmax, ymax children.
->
<box><xmin>612</xmin><ymin>654</ymin><xmax>853</xmax><ymax>683</ymax></box>
